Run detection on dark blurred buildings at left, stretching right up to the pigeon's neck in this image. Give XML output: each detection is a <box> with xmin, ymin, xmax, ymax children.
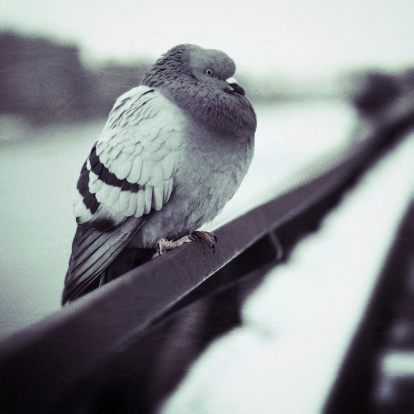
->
<box><xmin>0</xmin><ymin>33</ymin><xmax>149</xmax><ymax>122</ymax></box>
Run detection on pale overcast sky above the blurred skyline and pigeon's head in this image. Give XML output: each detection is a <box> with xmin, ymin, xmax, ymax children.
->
<box><xmin>0</xmin><ymin>0</ymin><xmax>414</xmax><ymax>76</ymax></box>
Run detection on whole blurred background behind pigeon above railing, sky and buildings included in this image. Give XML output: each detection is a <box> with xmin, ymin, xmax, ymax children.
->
<box><xmin>0</xmin><ymin>0</ymin><xmax>414</xmax><ymax>336</ymax></box>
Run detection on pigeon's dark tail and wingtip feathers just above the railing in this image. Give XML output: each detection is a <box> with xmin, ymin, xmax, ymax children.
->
<box><xmin>62</xmin><ymin>220</ymin><xmax>150</xmax><ymax>305</ymax></box>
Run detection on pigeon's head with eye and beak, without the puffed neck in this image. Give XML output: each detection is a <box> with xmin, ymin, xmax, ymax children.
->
<box><xmin>143</xmin><ymin>44</ymin><xmax>244</xmax><ymax>95</ymax></box>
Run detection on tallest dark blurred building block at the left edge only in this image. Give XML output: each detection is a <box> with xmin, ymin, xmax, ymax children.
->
<box><xmin>0</xmin><ymin>33</ymin><xmax>90</xmax><ymax>120</ymax></box>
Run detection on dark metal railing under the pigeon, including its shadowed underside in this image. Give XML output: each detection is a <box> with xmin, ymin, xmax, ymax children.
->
<box><xmin>0</xmin><ymin>85</ymin><xmax>414</xmax><ymax>413</ymax></box>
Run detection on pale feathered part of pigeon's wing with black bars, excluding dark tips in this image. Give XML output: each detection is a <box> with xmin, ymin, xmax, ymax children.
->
<box><xmin>74</xmin><ymin>86</ymin><xmax>185</xmax><ymax>227</ymax></box>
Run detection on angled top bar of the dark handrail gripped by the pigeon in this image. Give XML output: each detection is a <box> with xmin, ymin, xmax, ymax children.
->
<box><xmin>0</xmin><ymin>96</ymin><xmax>414</xmax><ymax>413</ymax></box>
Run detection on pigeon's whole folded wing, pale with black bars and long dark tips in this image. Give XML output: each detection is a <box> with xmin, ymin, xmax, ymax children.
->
<box><xmin>63</xmin><ymin>86</ymin><xmax>184</xmax><ymax>302</ymax></box>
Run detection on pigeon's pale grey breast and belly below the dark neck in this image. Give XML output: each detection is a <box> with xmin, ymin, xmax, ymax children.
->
<box><xmin>132</xmin><ymin>120</ymin><xmax>253</xmax><ymax>247</ymax></box>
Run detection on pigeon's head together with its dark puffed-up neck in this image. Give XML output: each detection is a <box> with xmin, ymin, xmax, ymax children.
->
<box><xmin>142</xmin><ymin>44</ymin><xmax>256</xmax><ymax>137</ymax></box>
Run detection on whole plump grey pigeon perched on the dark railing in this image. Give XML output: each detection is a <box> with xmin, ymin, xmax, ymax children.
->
<box><xmin>62</xmin><ymin>44</ymin><xmax>257</xmax><ymax>305</ymax></box>
